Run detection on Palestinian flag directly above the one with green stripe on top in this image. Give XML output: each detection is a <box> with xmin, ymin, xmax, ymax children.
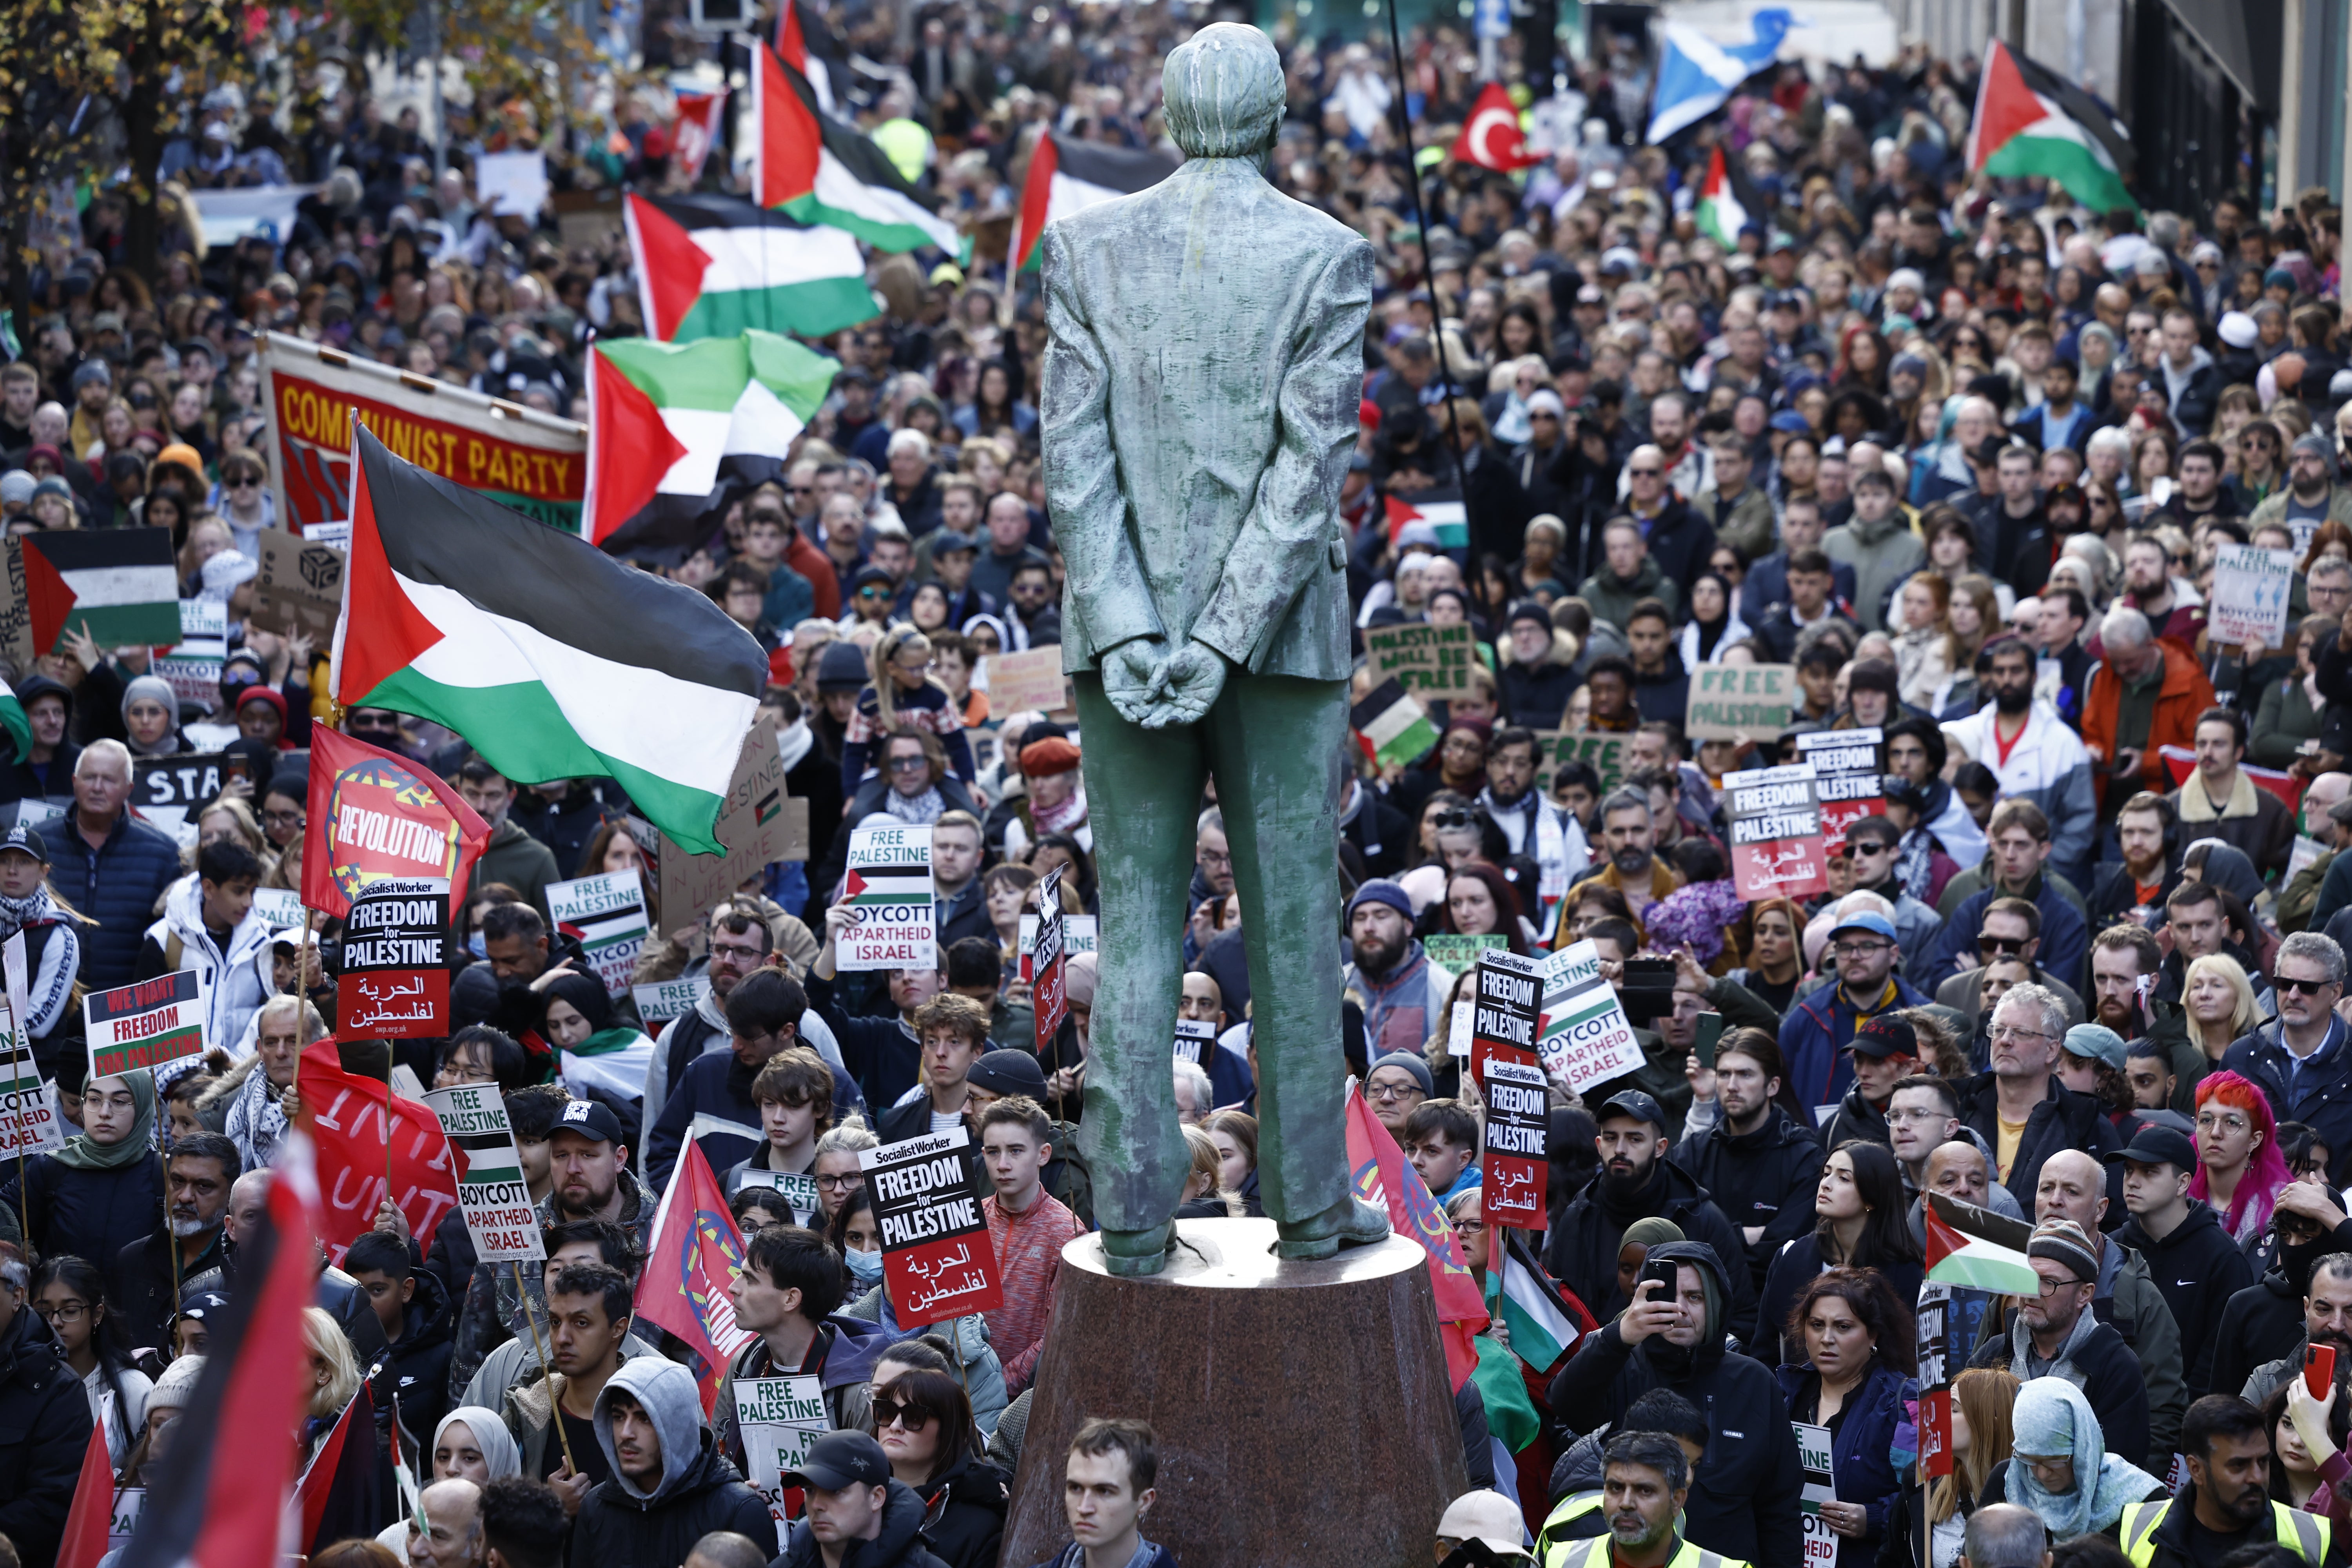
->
<box><xmin>621</xmin><ymin>193</ymin><xmax>877</xmax><ymax>343</ymax></box>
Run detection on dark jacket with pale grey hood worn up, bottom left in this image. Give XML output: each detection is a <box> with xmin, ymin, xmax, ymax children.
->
<box><xmin>574</xmin><ymin>1356</ymin><xmax>776</xmax><ymax>1568</ymax></box>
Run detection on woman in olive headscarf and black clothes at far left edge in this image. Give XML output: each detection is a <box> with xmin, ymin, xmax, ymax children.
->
<box><xmin>0</xmin><ymin>1067</ymin><xmax>162</xmax><ymax>1258</ymax></box>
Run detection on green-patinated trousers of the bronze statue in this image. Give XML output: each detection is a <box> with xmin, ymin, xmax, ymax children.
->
<box><xmin>1075</xmin><ymin>675</ymin><xmax>1348</xmax><ymax>1248</ymax></box>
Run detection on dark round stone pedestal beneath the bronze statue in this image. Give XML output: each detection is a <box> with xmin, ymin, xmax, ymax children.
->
<box><xmin>1004</xmin><ymin>1220</ymin><xmax>1468</xmax><ymax>1568</ymax></box>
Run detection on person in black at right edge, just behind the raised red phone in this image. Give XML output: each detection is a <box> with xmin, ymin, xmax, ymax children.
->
<box><xmin>2211</xmin><ymin>1180</ymin><xmax>2352</xmax><ymax>1399</ymax></box>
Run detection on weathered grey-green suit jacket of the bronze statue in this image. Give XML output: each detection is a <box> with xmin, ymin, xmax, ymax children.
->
<box><xmin>1040</xmin><ymin>158</ymin><xmax>1374</xmax><ymax>679</ymax></box>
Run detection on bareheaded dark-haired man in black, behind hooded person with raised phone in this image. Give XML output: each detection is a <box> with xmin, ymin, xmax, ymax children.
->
<box><xmin>1668</xmin><ymin>1030</ymin><xmax>1820</xmax><ymax>1290</ymax></box>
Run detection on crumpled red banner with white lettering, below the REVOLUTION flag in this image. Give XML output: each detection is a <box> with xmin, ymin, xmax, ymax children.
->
<box><xmin>294</xmin><ymin>1037</ymin><xmax>456</xmax><ymax>1265</ymax></box>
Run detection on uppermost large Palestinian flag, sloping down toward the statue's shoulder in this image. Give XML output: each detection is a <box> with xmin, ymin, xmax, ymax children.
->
<box><xmin>750</xmin><ymin>49</ymin><xmax>971</xmax><ymax>261</ymax></box>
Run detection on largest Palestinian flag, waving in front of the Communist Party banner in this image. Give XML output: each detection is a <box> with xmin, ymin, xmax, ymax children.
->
<box><xmin>332</xmin><ymin>423</ymin><xmax>767</xmax><ymax>853</ymax></box>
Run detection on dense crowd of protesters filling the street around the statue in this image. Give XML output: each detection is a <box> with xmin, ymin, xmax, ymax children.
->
<box><xmin>0</xmin><ymin>0</ymin><xmax>2352</xmax><ymax>1568</ymax></box>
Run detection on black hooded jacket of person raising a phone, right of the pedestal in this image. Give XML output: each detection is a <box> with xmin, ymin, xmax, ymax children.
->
<box><xmin>1550</xmin><ymin>1241</ymin><xmax>1804</xmax><ymax>1563</ymax></box>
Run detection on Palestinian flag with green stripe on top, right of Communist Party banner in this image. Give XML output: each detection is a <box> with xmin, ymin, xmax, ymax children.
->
<box><xmin>581</xmin><ymin>332</ymin><xmax>840</xmax><ymax>555</ymax></box>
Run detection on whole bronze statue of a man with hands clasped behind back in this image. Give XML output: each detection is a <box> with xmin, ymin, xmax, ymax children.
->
<box><xmin>1040</xmin><ymin>21</ymin><xmax>1388</xmax><ymax>1274</ymax></box>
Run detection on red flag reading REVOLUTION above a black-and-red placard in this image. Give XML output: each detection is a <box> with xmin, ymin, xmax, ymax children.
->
<box><xmin>301</xmin><ymin>729</ymin><xmax>489</xmax><ymax>919</ymax></box>
